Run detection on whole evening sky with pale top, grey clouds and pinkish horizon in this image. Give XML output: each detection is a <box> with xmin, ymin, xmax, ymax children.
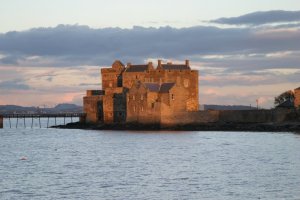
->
<box><xmin>0</xmin><ymin>0</ymin><xmax>300</xmax><ymax>108</ymax></box>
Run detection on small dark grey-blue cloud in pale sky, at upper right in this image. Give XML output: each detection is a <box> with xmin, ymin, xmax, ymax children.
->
<box><xmin>210</xmin><ymin>10</ymin><xmax>300</xmax><ymax>25</ymax></box>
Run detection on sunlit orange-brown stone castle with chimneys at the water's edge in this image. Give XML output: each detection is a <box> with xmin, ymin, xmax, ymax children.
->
<box><xmin>83</xmin><ymin>60</ymin><xmax>199</xmax><ymax>124</ymax></box>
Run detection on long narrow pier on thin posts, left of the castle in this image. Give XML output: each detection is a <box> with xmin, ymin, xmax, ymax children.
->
<box><xmin>0</xmin><ymin>113</ymin><xmax>86</xmax><ymax>128</ymax></box>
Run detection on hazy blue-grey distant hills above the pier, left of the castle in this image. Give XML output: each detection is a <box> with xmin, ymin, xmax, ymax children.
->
<box><xmin>0</xmin><ymin>103</ymin><xmax>83</xmax><ymax>114</ymax></box>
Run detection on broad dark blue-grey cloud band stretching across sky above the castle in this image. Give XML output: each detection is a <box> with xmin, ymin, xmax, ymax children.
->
<box><xmin>0</xmin><ymin>25</ymin><xmax>300</xmax><ymax>66</ymax></box>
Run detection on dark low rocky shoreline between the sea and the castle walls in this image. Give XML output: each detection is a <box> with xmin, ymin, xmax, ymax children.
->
<box><xmin>52</xmin><ymin>122</ymin><xmax>300</xmax><ymax>133</ymax></box>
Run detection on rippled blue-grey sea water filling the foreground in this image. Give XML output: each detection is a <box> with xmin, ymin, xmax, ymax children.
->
<box><xmin>0</xmin><ymin>119</ymin><xmax>300</xmax><ymax>200</ymax></box>
